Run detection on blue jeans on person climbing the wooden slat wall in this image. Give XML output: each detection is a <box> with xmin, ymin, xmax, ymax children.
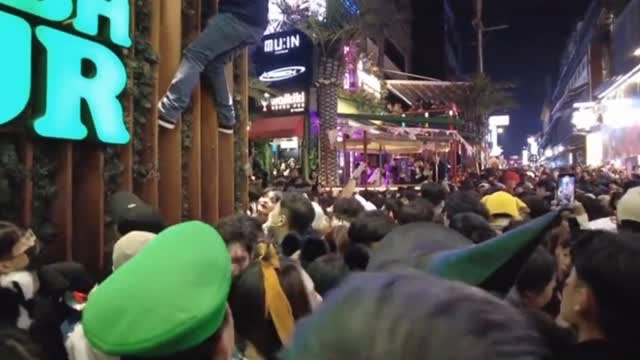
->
<box><xmin>159</xmin><ymin>13</ymin><xmax>264</xmax><ymax>127</ymax></box>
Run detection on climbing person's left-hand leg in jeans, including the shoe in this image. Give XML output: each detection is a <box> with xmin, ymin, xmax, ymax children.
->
<box><xmin>158</xmin><ymin>14</ymin><xmax>254</xmax><ymax>129</ymax></box>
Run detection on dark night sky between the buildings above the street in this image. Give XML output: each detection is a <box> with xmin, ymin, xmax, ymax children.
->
<box><xmin>414</xmin><ymin>0</ymin><xmax>590</xmax><ymax>155</ymax></box>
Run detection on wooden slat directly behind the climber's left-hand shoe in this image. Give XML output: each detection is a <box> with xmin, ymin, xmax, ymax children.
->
<box><xmin>154</xmin><ymin>0</ymin><xmax>182</xmax><ymax>224</ymax></box>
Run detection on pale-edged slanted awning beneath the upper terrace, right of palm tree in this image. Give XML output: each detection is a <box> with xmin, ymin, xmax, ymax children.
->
<box><xmin>386</xmin><ymin>80</ymin><xmax>471</xmax><ymax>105</ymax></box>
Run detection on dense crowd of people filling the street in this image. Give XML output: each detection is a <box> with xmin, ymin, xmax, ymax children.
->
<box><xmin>0</xmin><ymin>166</ymin><xmax>640</xmax><ymax>360</ymax></box>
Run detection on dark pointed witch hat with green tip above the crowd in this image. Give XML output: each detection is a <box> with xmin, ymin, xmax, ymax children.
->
<box><xmin>367</xmin><ymin>212</ymin><xmax>558</xmax><ymax>296</ymax></box>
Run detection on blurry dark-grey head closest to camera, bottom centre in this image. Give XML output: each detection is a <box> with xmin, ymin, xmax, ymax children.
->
<box><xmin>279</xmin><ymin>272</ymin><xmax>548</xmax><ymax>360</ymax></box>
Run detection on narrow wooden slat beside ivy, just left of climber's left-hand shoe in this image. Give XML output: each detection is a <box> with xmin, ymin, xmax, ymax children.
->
<box><xmin>136</xmin><ymin>1</ymin><xmax>162</xmax><ymax>207</ymax></box>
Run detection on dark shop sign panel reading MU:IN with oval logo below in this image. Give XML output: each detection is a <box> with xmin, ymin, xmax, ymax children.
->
<box><xmin>255</xmin><ymin>30</ymin><xmax>313</xmax><ymax>91</ymax></box>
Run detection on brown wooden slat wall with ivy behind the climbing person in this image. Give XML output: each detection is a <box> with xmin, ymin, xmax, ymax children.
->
<box><xmin>3</xmin><ymin>0</ymin><xmax>248</xmax><ymax>274</ymax></box>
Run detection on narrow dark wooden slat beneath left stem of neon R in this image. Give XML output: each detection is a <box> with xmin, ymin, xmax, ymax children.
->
<box><xmin>51</xmin><ymin>142</ymin><xmax>73</xmax><ymax>260</ymax></box>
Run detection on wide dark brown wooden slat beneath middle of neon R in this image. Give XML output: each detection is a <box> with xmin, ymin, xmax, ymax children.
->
<box><xmin>72</xmin><ymin>144</ymin><xmax>105</xmax><ymax>274</ymax></box>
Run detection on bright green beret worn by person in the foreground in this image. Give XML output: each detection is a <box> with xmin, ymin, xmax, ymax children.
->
<box><xmin>82</xmin><ymin>221</ymin><xmax>231</xmax><ymax>357</ymax></box>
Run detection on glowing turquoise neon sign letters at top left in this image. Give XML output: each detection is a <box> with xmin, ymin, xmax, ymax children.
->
<box><xmin>0</xmin><ymin>0</ymin><xmax>132</xmax><ymax>144</ymax></box>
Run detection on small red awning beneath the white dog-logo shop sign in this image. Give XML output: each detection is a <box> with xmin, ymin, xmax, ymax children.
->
<box><xmin>249</xmin><ymin>115</ymin><xmax>304</xmax><ymax>141</ymax></box>
